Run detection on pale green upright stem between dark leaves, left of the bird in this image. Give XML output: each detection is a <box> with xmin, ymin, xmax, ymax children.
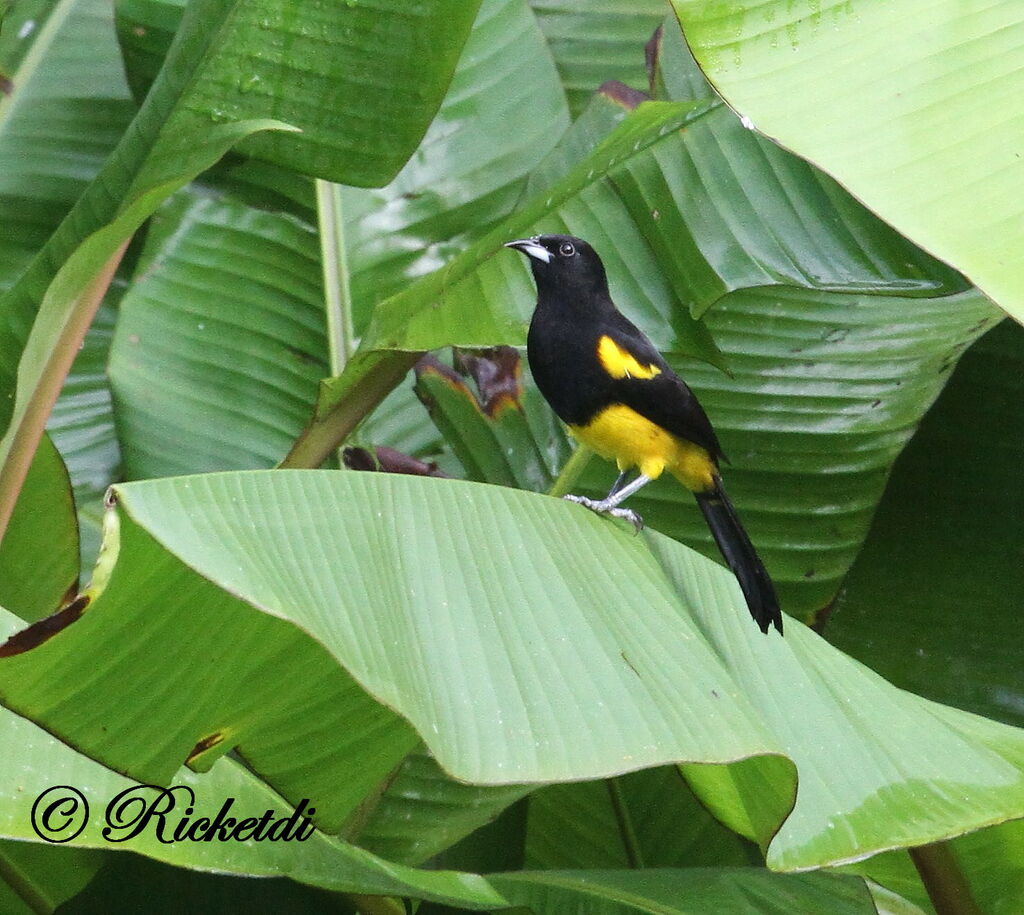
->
<box><xmin>316</xmin><ymin>178</ymin><xmax>355</xmax><ymax>376</ymax></box>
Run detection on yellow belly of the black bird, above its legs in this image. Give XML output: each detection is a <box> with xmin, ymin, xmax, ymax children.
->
<box><xmin>569</xmin><ymin>403</ymin><xmax>716</xmax><ymax>492</ymax></box>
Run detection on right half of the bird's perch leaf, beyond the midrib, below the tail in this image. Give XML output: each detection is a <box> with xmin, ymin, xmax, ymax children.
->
<box><xmin>652</xmin><ymin>539</ymin><xmax>1024</xmax><ymax>870</ymax></box>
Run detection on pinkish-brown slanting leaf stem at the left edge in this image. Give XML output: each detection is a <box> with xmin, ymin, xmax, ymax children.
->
<box><xmin>0</xmin><ymin>241</ymin><xmax>128</xmax><ymax>539</ymax></box>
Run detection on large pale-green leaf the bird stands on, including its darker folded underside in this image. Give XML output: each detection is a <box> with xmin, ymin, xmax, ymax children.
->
<box><xmin>0</xmin><ymin>472</ymin><xmax>1024</xmax><ymax>869</ymax></box>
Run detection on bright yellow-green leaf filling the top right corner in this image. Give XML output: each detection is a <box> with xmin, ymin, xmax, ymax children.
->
<box><xmin>672</xmin><ymin>0</ymin><xmax>1024</xmax><ymax>318</ymax></box>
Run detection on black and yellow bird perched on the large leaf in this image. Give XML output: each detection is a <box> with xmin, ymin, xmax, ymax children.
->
<box><xmin>505</xmin><ymin>234</ymin><xmax>782</xmax><ymax>634</ymax></box>
